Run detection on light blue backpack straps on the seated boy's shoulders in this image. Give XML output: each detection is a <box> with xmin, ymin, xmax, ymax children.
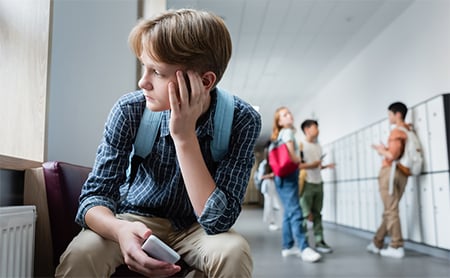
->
<box><xmin>127</xmin><ymin>88</ymin><xmax>234</xmax><ymax>185</ymax></box>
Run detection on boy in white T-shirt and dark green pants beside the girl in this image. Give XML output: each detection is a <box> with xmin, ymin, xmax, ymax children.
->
<box><xmin>300</xmin><ymin>120</ymin><xmax>335</xmax><ymax>253</ymax></box>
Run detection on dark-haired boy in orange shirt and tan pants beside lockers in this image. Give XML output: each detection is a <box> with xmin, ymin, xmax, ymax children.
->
<box><xmin>367</xmin><ymin>102</ymin><xmax>410</xmax><ymax>258</ymax></box>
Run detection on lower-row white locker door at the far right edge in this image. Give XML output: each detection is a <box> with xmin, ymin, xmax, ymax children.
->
<box><xmin>431</xmin><ymin>173</ymin><xmax>450</xmax><ymax>249</ymax></box>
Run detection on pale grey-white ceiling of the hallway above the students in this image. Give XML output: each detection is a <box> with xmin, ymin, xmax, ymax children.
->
<box><xmin>167</xmin><ymin>0</ymin><xmax>413</xmax><ymax>148</ymax></box>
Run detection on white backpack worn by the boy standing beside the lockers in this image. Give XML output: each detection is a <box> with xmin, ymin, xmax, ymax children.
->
<box><xmin>397</xmin><ymin>127</ymin><xmax>423</xmax><ymax>176</ymax></box>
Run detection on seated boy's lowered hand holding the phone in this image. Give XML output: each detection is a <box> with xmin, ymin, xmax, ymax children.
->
<box><xmin>117</xmin><ymin>222</ymin><xmax>181</xmax><ymax>277</ymax></box>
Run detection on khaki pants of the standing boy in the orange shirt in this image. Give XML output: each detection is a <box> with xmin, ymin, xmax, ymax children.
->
<box><xmin>373</xmin><ymin>167</ymin><xmax>408</xmax><ymax>248</ymax></box>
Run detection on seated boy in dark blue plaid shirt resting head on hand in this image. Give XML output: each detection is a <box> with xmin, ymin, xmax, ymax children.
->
<box><xmin>56</xmin><ymin>9</ymin><xmax>261</xmax><ymax>277</ymax></box>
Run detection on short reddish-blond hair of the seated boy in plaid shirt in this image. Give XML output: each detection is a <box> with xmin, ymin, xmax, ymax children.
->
<box><xmin>128</xmin><ymin>9</ymin><xmax>232</xmax><ymax>85</ymax></box>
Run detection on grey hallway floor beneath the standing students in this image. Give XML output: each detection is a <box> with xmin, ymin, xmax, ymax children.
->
<box><xmin>234</xmin><ymin>207</ymin><xmax>450</xmax><ymax>278</ymax></box>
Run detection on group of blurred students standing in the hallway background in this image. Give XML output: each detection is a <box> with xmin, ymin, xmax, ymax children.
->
<box><xmin>254</xmin><ymin>102</ymin><xmax>412</xmax><ymax>262</ymax></box>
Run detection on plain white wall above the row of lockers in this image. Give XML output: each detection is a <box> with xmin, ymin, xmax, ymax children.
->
<box><xmin>295</xmin><ymin>0</ymin><xmax>450</xmax><ymax>146</ymax></box>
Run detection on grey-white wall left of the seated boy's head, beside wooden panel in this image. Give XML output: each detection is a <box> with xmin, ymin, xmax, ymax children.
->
<box><xmin>47</xmin><ymin>0</ymin><xmax>138</xmax><ymax>166</ymax></box>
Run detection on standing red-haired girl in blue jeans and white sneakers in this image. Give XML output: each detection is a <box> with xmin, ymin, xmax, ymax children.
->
<box><xmin>271</xmin><ymin>107</ymin><xmax>321</xmax><ymax>262</ymax></box>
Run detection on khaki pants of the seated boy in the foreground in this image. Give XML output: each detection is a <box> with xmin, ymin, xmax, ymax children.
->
<box><xmin>55</xmin><ymin>214</ymin><xmax>253</xmax><ymax>277</ymax></box>
